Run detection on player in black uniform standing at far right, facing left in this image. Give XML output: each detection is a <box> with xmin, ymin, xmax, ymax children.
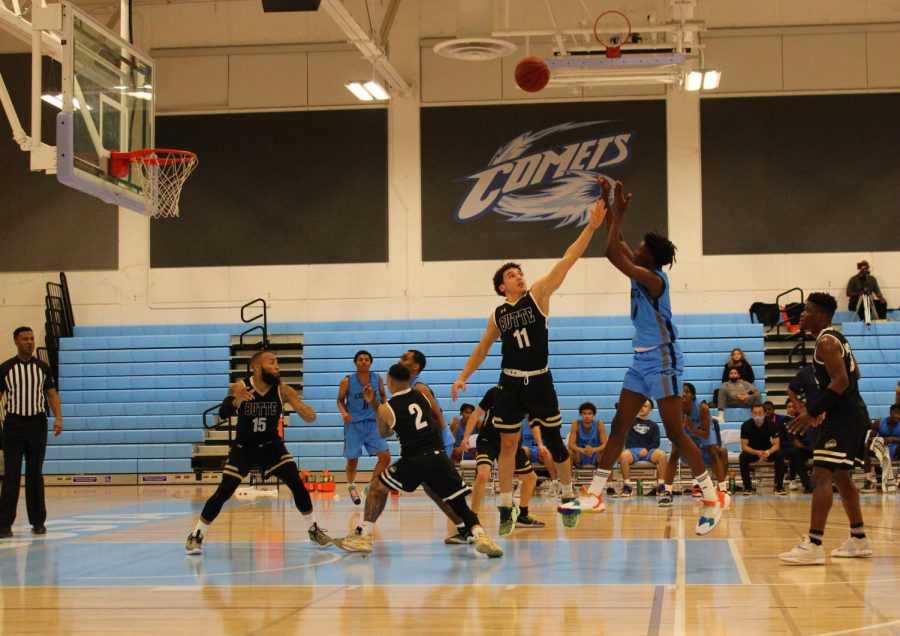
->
<box><xmin>780</xmin><ymin>292</ymin><xmax>872</xmax><ymax>565</ymax></box>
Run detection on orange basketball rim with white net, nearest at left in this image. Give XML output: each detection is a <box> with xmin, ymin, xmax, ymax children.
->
<box><xmin>109</xmin><ymin>148</ymin><xmax>197</xmax><ymax>219</ymax></box>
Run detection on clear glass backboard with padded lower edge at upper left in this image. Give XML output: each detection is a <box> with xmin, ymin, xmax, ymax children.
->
<box><xmin>56</xmin><ymin>3</ymin><xmax>155</xmax><ymax>212</ymax></box>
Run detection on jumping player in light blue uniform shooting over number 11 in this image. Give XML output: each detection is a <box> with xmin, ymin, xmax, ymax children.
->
<box><xmin>558</xmin><ymin>179</ymin><xmax>730</xmax><ymax>535</ymax></box>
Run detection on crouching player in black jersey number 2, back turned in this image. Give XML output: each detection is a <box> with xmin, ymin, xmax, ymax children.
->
<box><xmin>334</xmin><ymin>363</ymin><xmax>503</xmax><ymax>557</ymax></box>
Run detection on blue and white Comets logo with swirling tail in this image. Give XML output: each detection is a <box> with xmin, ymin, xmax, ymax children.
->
<box><xmin>456</xmin><ymin>121</ymin><xmax>634</xmax><ymax>227</ymax></box>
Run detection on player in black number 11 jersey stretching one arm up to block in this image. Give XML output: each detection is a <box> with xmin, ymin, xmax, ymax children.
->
<box><xmin>450</xmin><ymin>190</ymin><xmax>607</xmax><ymax>536</ymax></box>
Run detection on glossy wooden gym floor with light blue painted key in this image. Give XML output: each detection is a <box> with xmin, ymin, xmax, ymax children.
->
<box><xmin>0</xmin><ymin>484</ymin><xmax>900</xmax><ymax>636</ymax></box>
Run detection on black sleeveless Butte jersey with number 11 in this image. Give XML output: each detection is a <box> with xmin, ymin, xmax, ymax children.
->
<box><xmin>494</xmin><ymin>290</ymin><xmax>550</xmax><ymax>371</ymax></box>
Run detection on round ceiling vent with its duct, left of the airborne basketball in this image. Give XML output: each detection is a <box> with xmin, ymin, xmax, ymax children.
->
<box><xmin>434</xmin><ymin>0</ymin><xmax>516</xmax><ymax>62</ymax></box>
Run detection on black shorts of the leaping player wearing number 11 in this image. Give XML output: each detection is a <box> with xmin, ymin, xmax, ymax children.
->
<box><xmin>494</xmin><ymin>371</ymin><xmax>562</xmax><ymax>433</ymax></box>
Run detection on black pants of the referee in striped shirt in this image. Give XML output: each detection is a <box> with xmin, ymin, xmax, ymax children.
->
<box><xmin>0</xmin><ymin>414</ymin><xmax>47</xmax><ymax>528</ymax></box>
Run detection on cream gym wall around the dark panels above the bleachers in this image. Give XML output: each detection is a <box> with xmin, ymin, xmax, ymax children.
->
<box><xmin>0</xmin><ymin>0</ymin><xmax>900</xmax><ymax>336</ymax></box>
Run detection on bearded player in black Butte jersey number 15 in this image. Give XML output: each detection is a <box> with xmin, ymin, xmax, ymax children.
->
<box><xmin>185</xmin><ymin>351</ymin><xmax>331</xmax><ymax>554</ymax></box>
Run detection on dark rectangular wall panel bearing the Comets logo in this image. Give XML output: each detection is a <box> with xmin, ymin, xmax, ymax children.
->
<box><xmin>422</xmin><ymin>99</ymin><xmax>668</xmax><ymax>262</ymax></box>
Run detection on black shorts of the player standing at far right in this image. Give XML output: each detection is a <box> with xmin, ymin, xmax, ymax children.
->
<box><xmin>813</xmin><ymin>407</ymin><xmax>869</xmax><ymax>471</ymax></box>
